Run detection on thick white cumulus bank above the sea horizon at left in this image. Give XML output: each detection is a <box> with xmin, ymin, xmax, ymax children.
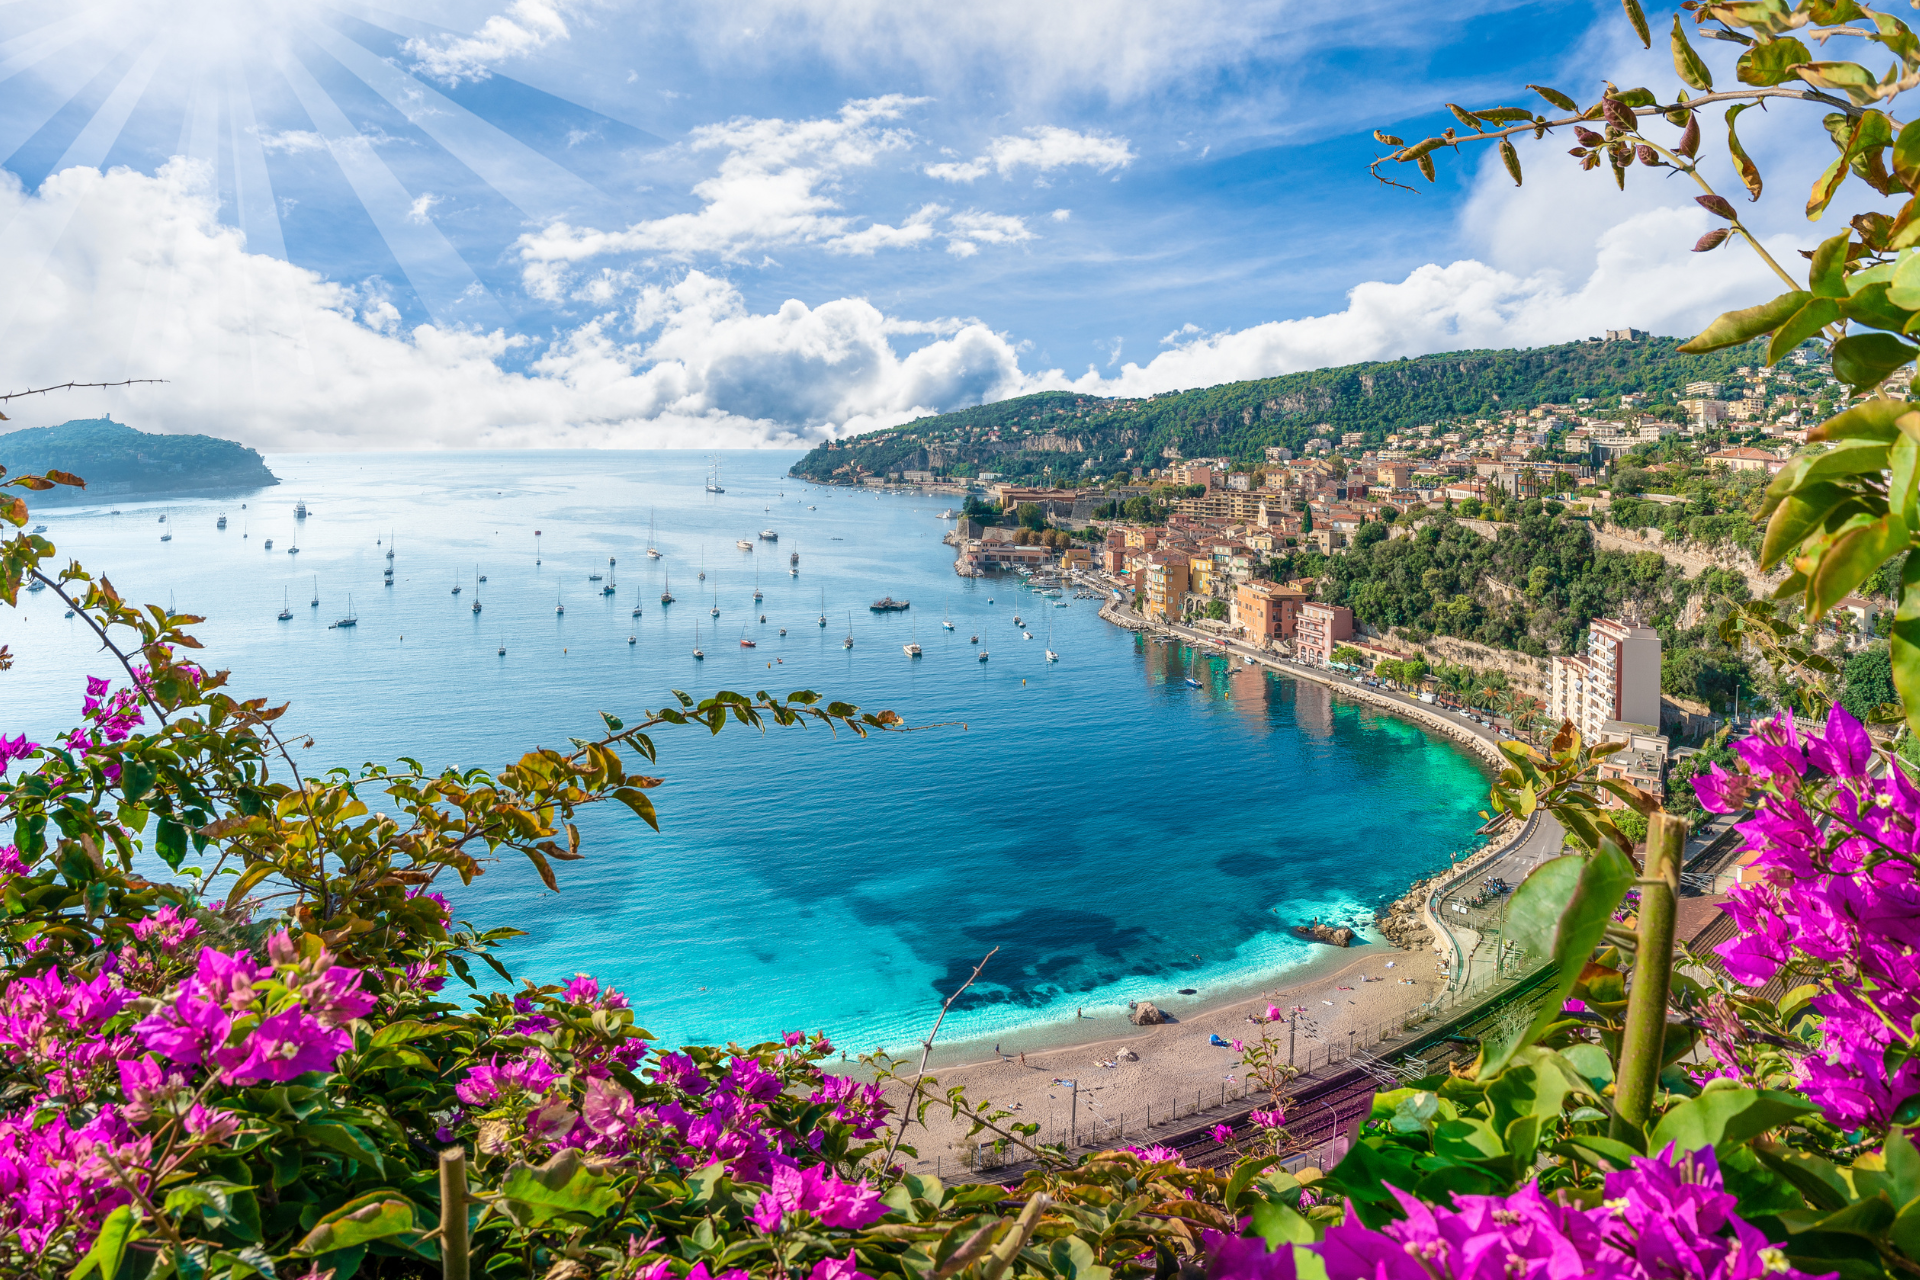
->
<box><xmin>0</xmin><ymin>159</ymin><xmax>1021</xmax><ymax>449</ymax></box>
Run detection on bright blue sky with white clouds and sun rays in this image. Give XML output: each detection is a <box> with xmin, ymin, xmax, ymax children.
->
<box><xmin>0</xmin><ymin>0</ymin><xmax>1860</xmax><ymax>451</ymax></box>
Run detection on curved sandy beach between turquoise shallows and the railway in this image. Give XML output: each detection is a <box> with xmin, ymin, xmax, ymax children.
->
<box><xmin>867</xmin><ymin>944</ymin><xmax>1446</xmax><ymax>1173</ymax></box>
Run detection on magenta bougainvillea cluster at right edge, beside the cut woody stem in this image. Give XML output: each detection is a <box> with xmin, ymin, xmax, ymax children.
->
<box><xmin>1693</xmin><ymin>702</ymin><xmax>1920</xmax><ymax>1128</ymax></box>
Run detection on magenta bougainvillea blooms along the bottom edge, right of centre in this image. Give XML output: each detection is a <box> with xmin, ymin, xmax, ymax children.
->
<box><xmin>1206</xmin><ymin>1146</ymin><xmax>1807</xmax><ymax>1280</ymax></box>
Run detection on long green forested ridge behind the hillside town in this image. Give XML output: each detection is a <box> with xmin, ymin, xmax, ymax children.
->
<box><xmin>793</xmin><ymin>338</ymin><xmax>1763</xmax><ymax>480</ymax></box>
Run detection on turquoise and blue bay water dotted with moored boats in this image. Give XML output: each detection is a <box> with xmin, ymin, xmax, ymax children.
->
<box><xmin>0</xmin><ymin>451</ymin><xmax>1484</xmax><ymax>1050</ymax></box>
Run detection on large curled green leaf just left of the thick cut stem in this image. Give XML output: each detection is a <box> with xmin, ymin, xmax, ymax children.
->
<box><xmin>1478</xmin><ymin>841</ymin><xmax>1634</xmax><ymax>1079</ymax></box>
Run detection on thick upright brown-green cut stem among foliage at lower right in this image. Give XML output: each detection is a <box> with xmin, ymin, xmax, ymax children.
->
<box><xmin>1611</xmin><ymin>810</ymin><xmax>1688</xmax><ymax>1140</ymax></box>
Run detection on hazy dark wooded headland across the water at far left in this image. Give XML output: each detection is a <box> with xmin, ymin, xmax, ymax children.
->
<box><xmin>0</xmin><ymin>418</ymin><xmax>280</xmax><ymax>507</ymax></box>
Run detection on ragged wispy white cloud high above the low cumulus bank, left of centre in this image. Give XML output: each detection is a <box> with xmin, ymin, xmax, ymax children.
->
<box><xmin>515</xmin><ymin>94</ymin><xmax>931</xmax><ymax>299</ymax></box>
